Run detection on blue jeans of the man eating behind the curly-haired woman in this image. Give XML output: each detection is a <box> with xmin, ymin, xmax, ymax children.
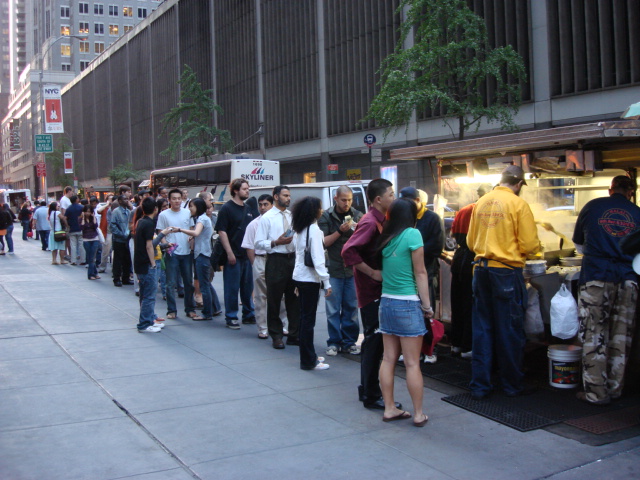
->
<box><xmin>325</xmin><ymin>277</ymin><xmax>360</xmax><ymax>348</ymax></box>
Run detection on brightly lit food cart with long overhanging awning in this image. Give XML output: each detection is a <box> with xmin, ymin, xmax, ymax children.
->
<box><xmin>391</xmin><ymin>120</ymin><xmax>640</xmax><ymax>390</ymax></box>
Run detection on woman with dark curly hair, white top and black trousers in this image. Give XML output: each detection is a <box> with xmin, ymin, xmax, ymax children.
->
<box><xmin>291</xmin><ymin>197</ymin><xmax>331</xmax><ymax>370</ymax></box>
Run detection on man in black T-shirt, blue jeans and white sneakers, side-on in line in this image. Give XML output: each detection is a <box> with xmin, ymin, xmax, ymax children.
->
<box><xmin>133</xmin><ymin>198</ymin><xmax>171</xmax><ymax>333</ymax></box>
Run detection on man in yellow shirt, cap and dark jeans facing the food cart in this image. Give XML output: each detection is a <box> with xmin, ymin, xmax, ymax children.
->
<box><xmin>467</xmin><ymin>165</ymin><xmax>540</xmax><ymax>399</ymax></box>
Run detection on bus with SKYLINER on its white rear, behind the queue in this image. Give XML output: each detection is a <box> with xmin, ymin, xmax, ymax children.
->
<box><xmin>149</xmin><ymin>158</ymin><xmax>280</xmax><ymax>205</ymax></box>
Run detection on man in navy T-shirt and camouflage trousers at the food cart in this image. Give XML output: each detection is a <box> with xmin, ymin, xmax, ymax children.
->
<box><xmin>573</xmin><ymin>175</ymin><xmax>640</xmax><ymax>405</ymax></box>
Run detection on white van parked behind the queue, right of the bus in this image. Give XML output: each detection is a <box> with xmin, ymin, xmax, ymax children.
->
<box><xmin>250</xmin><ymin>180</ymin><xmax>371</xmax><ymax>213</ymax></box>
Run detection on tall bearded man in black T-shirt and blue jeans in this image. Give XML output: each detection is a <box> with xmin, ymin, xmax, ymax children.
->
<box><xmin>216</xmin><ymin>178</ymin><xmax>256</xmax><ymax>330</ymax></box>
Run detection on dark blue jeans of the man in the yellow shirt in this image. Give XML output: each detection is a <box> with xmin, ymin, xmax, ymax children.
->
<box><xmin>470</xmin><ymin>265</ymin><xmax>527</xmax><ymax>396</ymax></box>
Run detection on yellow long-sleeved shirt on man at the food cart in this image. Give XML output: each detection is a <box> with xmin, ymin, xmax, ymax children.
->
<box><xmin>467</xmin><ymin>187</ymin><xmax>540</xmax><ymax>268</ymax></box>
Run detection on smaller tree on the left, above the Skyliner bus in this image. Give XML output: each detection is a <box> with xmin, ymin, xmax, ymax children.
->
<box><xmin>160</xmin><ymin>65</ymin><xmax>233</xmax><ymax>161</ymax></box>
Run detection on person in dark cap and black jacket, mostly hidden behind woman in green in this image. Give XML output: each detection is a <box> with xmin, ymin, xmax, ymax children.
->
<box><xmin>400</xmin><ymin>187</ymin><xmax>444</xmax><ymax>363</ymax></box>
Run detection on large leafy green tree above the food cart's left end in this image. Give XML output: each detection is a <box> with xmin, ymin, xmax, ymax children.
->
<box><xmin>365</xmin><ymin>0</ymin><xmax>526</xmax><ymax>140</ymax></box>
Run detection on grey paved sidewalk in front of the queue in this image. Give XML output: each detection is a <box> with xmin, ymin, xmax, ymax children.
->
<box><xmin>0</xmin><ymin>242</ymin><xmax>640</xmax><ymax>480</ymax></box>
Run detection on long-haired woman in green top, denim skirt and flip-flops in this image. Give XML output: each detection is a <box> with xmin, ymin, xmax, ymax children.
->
<box><xmin>379</xmin><ymin>198</ymin><xmax>433</xmax><ymax>427</ymax></box>
